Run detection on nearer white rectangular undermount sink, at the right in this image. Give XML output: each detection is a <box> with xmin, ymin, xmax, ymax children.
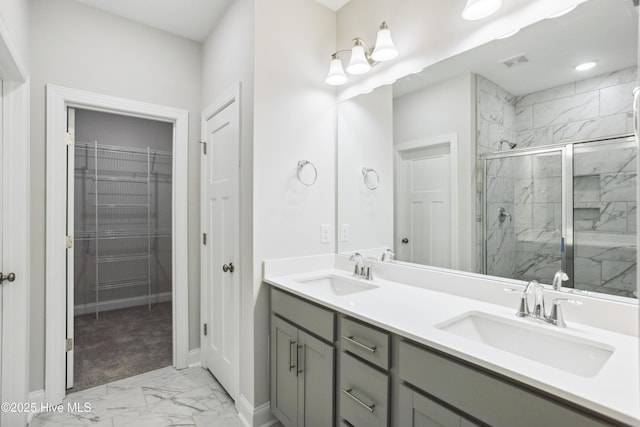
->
<box><xmin>436</xmin><ymin>312</ymin><xmax>615</xmax><ymax>377</ymax></box>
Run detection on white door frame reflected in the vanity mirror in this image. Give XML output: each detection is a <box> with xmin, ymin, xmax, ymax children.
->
<box><xmin>393</xmin><ymin>133</ymin><xmax>460</xmax><ymax>270</ymax></box>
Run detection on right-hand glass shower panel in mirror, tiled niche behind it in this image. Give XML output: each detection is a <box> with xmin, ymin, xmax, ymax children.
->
<box><xmin>573</xmin><ymin>140</ymin><xmax>637</xmax><ymax>297</ymax></box>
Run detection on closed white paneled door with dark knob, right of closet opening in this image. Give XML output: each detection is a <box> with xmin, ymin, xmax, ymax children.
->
<box><xmin>202</xmin><ymin>93</ymin><xmax>240</xmax><ymax>400</ymax></box>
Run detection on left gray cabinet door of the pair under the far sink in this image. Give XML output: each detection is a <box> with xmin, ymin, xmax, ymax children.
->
<box><xmin>271</xmin><ymin>316</ymin><xmax>299</xmax><ymax>427</ymax></box>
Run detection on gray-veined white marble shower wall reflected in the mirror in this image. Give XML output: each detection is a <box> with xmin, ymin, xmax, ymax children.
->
<box><xmin>476</xmin><ymin>68</ymin><xmax>637</xmax><ymax>296</ymax></box>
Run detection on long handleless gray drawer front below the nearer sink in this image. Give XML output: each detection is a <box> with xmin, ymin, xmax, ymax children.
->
<box><xmin>398</xmin><ymin>341</ymin><xmax>612</xmax><ymax>427</ymax></box>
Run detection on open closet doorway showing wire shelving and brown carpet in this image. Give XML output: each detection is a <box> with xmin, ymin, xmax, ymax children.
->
<box><xmin>67</xmin><ymin>108</ymin><xmax>173</xmax><ymax>391</ymax></box>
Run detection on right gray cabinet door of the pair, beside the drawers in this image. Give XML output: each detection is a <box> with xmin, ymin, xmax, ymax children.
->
<box><xmin>298</xmin><ymin>330</ymin><xmax>335</xmax><ymax>427</ymax></box>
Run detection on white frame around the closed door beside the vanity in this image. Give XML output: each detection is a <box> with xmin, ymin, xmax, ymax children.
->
<box><xmin>200</xmin><ymin>82</ymin><xmax>243</xmax><ymax>402</ymax></box>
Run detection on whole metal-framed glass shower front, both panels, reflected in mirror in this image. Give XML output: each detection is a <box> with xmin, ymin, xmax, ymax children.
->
<box><xmin>483</xmin><ymin>137</ymin><xmax>637</xmax><ymax>298</ymax></box>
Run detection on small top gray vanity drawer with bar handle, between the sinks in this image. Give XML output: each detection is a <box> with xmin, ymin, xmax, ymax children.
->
<box><xmin>339</xmin><ymin>317</ymin><xmax>391</xmax><ymax>371</ymax></box>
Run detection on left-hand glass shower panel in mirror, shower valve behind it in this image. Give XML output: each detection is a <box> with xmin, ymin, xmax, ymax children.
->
<box><xmin>485</xmin><ymin>149</ymin><xmax>563</xmax><ymax>282</ymax></box>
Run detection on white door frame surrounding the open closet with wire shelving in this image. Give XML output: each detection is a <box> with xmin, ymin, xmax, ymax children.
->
<box><xmin>45</xmin><ymin>85</ymin><xmax>189</xmax><ymax>403</ymax></box>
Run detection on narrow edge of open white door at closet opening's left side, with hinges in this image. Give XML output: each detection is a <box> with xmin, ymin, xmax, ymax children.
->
<box><xmin>66</xmin><ymin>108</ymin><xmax>76</xmax><ymax>388</ymax></box>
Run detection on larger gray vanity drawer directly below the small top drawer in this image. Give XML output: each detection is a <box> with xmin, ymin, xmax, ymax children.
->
<box><xmin>338</xmin><ymin>353</ymin><xmax>389</xmax><ymax>427</ymax></box>
